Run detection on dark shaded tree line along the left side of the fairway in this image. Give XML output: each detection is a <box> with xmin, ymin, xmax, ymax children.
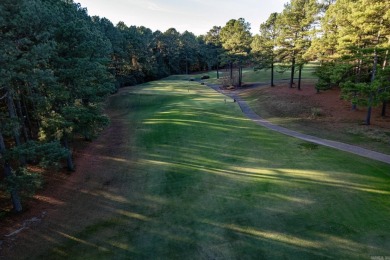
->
<box><xmin>0</xmin><ymin>0</ymin><xmax>253</xmax><ymax>212</ymax></box>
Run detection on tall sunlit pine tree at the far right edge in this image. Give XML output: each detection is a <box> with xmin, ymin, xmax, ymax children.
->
<box><xmin>330</xmin><ymin>0</ymin><xmax>390</xmax><ymax>125</ymax></box>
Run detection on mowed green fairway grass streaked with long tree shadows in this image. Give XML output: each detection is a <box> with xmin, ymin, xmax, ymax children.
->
<box><xmin>41</xmin><ymin>79</ymin><xmax>390</xmax><ymax>259</ymax></box>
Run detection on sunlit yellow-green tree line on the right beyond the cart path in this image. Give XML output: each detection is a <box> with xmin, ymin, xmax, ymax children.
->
<box><xmin>251</xmin><ymin>0</ymin><xmax>390</xmax><ymax>125</ymax></box>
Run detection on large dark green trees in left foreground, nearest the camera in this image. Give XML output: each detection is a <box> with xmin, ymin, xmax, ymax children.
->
<box><xmin>0</xmin><ymin>0</ymin><xmax>117</xmax><ymax>211</ymax></box>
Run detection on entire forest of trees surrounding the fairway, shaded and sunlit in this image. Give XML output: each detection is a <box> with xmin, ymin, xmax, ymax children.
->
<box><xmin>0</xmin><ymin>0</ymin><xmax>390</xmax><ymax>212</ymax></box>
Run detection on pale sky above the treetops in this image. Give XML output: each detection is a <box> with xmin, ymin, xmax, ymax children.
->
<box><xmin>74</xmin><ymin>0</ymin><xmax>289</xmax><ymax>35</ymax></box>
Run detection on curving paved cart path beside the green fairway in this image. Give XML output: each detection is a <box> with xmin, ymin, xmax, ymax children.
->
<box><xmin>208</xmin><ymin>85</ymin><xmax>390</xmax><ymax>164</ymax></box>
